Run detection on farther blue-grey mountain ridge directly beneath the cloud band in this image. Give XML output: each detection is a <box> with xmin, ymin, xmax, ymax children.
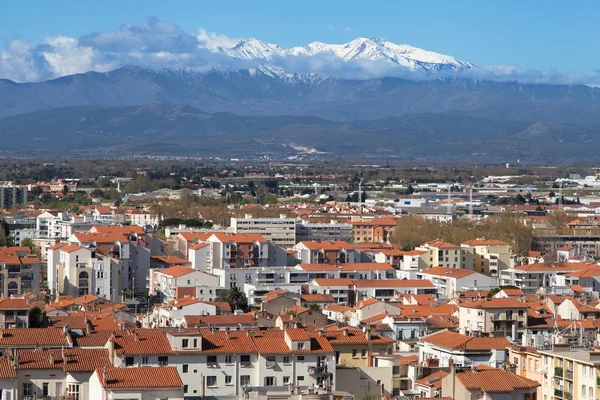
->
<box><xmin>0</xmin><ymin>67</ymin><xmax>600</xmax><ymax>124</ymax></box>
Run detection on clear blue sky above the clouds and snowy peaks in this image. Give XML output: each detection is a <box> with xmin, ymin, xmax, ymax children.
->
<box><xmin>0</xmin><ymin>0</ymin><xmax>600</xmax><ymax>82</ymax></box>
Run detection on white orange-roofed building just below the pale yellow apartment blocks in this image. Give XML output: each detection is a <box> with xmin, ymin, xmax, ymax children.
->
<box><xmin>416</xmin><ymin>267</ymin><xmax>498</xmax><ymax>299</ymax></box>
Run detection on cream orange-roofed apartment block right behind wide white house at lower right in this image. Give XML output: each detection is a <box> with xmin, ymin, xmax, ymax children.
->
<box><xmin>458</xmin><ymin>298</ymin><xmax>527</xmax><ymax>340</ymax></box>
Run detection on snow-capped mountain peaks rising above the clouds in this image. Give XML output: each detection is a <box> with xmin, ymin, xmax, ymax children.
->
<box><xmin>213</xmin><ymin>37</ymin><xmax>473</xmax><ymax>71</ymax></box>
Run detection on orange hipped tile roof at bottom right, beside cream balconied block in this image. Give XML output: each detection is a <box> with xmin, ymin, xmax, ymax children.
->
<box><xmin>456</xmin><ymin>368</ymin><xmax>540</xmax><ymax>392</ymax></box>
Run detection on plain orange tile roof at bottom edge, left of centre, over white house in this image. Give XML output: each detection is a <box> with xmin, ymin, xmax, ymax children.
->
<box><xmin>96</xmin><ymin>367</ymin><xmax>183</xmax><ymax>390</ymax></box>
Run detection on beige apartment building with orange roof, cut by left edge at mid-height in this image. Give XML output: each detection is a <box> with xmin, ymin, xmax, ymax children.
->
<box><xmin>0</xmin><ymin>246</ymin><xmax>41</xmax><ymax>297</ymax></box>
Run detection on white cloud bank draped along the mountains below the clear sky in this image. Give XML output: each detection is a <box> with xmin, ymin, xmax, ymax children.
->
<box><xmin>0</xmin><ymin>18</ymin><xmax>600</xmax><ymax>84</ymax></box>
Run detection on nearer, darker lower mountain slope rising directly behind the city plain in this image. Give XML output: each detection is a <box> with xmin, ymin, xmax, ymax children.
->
<box><xmin>0</xmin><ymin>105</ymin><xmax>600</xmax><ymax>162</ymax></box>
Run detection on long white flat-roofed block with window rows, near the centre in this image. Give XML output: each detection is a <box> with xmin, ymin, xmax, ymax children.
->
<box><xmin>231</xmin><ymin>214</ymin><xmax>296</xmax><ymax>248</ymax></box>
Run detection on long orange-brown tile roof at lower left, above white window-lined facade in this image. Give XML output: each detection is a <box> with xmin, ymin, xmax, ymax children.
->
<box><xmin>18</xmin><ymin>349</ymin><xmax>111</xmax><ymax>372</ymax></box>
